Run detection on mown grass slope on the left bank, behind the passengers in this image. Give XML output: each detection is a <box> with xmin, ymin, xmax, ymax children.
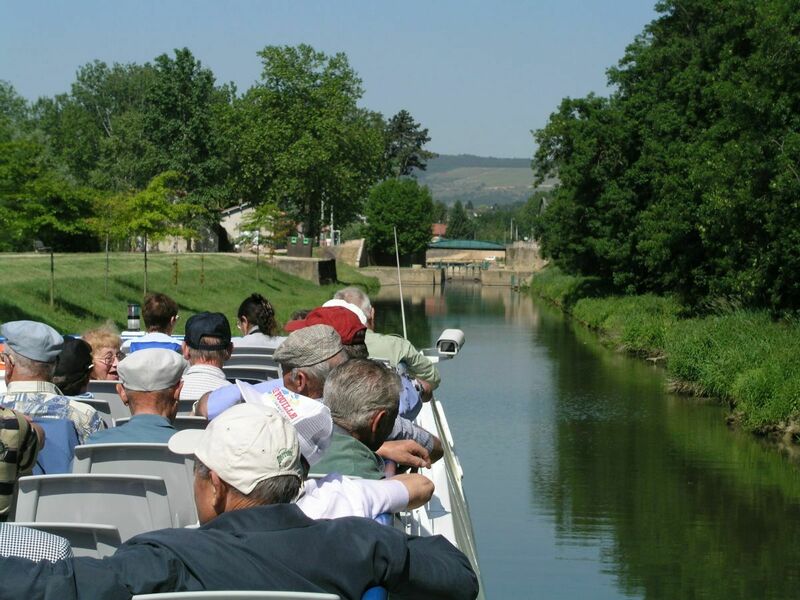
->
<box><xmin>0</xmin><ymin>253</ymin><xmax>378</xmax><ymax>333</ymax></box>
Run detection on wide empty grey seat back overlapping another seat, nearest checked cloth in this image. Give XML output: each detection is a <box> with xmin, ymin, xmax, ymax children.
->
<box><xmin>15</xmin><ymin>474</ymin><xmax>176</xmax><ymax>542</ymax></box>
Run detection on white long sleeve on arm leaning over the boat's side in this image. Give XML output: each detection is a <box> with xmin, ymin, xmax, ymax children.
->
<box><xmin>297</xmin><ymin>473</ymin><xmax>408</xmax><ymax>519</ymax></box>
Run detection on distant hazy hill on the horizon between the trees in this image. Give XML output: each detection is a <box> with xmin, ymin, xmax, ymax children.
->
<box><xmin>414</xmin><ymin>154</ymin><xmax>555</xmax><ymax>207</ymax></box>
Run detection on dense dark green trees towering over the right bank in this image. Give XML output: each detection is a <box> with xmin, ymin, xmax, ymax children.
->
<box><xmin>534</xmin><ymin>0</ymin><xmax>800</xmax><ymax>312</ymax></box>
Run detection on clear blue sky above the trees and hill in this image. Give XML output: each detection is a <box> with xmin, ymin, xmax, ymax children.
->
<box><xmin>0</xmin><ymin>0</ymin><xmax>656</xmax><ymax>158</ymax></box>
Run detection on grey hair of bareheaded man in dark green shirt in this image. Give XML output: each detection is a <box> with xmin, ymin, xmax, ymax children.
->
<box><xmin>323</xmin><ymin>358</ymin><xmax>400</xmax><ymax>433</ymax></box>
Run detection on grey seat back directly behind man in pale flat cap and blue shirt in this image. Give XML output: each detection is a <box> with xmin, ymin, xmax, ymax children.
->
<box><xmin>72</xmin><ymin>443</ymin><xmax>197</xmax><ymax>527</ymax></box>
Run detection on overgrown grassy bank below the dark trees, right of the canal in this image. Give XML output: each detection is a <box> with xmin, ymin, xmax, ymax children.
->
<box><xmin>531</xmin><ymin>267</ymin><xmax>800</xmax><ymax>433</ymax></box>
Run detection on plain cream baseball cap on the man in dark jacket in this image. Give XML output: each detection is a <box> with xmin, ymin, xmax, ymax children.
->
<box><xmin>169</xmin><ymin>403</ymin><xmax>303</xmax><ymax>494</ymax></box>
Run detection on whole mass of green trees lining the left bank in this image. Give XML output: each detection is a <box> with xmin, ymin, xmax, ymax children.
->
<box><xmin>0</xmin><ymin>45</ymin><xmax>432</xmax><ymax>251</ymax></box>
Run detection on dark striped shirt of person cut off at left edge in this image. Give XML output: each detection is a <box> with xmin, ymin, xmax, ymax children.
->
<box><xmin>0</xmin><ymin>408</ymin><xmax>39</xmax><ymax>521</ymax></box>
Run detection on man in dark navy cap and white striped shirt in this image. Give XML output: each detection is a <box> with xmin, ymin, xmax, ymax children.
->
<box><xmin>180</xmin><ymin>312</ymin><xmax>233</xmax><ymax>401</ymax></box>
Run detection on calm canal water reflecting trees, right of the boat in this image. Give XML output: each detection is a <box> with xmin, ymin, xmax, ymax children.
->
<box><xmin>375</xmin><ymin>284</ymin><xmax>800</xmax><ymax>600</ymax></box>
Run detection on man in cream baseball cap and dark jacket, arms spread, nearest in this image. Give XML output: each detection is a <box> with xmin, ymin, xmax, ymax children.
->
<box><xmin>0</xmin><ymin>404</ymin><xmax>478</xmax><ymax>600</ymax></box>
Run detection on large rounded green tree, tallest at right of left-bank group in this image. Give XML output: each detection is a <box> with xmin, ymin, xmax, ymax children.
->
<box><xmin>231</xmin><ymin>45</ymin><xmax>383</xmax><ymax>237</ymax></box>
